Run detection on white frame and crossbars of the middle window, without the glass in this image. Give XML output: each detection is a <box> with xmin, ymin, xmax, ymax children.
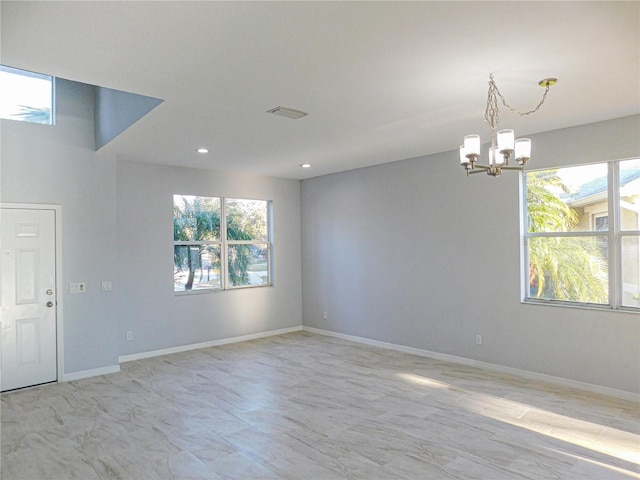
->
<box><xmin>172</xmin><ymin>193</ymin><xmax>273</xmax><ymax>295</ymax></box>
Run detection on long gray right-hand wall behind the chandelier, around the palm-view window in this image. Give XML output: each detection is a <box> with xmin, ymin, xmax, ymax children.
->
<box><xmin>302</xmin><ymin>116</ymin><xmax>640</xmax><ymax>393</ymax></box>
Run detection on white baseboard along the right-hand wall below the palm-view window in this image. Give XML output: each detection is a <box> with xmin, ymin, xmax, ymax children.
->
<box><xmin>302</xmin><ymin>326</ymin><xmax>640</xmax><ymax>402</ymax></box>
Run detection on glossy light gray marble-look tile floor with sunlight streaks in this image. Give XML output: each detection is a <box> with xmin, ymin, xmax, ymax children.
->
<box><xmin>0</xmin><ymin>332</ymin><xmax>640</xmax><ymax>480</ymax></box>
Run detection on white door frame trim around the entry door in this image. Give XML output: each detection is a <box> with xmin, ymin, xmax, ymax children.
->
<box><xmin>0</xmin><ymin>202</ymin><xmax>64</xmax><ymax>383</ymax></box>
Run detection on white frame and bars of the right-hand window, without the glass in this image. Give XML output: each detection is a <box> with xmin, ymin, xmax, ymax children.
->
<box><xmin>520</xmin><ymin>157</ymin><xmax>640</xmax><ymax>313</ymax></box>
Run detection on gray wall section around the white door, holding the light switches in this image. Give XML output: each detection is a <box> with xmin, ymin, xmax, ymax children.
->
<box><xmin>1</xmin><ymin>79</ymin><xmax>118</xmax><ymax>373</ymax></box>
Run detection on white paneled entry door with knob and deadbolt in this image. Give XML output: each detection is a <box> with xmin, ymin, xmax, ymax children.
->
<box><xmin>0</xmin><ymin>208</ymin><xmax>58</xmax><ymax>391</ymax></box>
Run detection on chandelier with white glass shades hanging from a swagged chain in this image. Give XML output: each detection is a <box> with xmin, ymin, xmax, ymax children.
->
<box><xmin>460</xmin><ymin>74</ymin><xmax>558</xmax><ymax>177</ymax></box>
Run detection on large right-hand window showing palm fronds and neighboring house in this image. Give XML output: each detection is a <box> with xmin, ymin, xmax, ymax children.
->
<box><xmin>524</xmin><ymin>159</ymin><xmax>640</xmax><ymax>308</ymax></box>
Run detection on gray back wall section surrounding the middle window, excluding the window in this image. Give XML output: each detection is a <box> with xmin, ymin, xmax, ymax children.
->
<box><xmin>117</xmin><ymin>161</ymin><xmax>302</xmax><ymax>354</ymax></box>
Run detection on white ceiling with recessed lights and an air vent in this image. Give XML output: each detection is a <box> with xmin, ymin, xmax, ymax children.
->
<box><xmin>0</xmin><ymin>1</ymin><xmax>640</xmax><ymax>179</ymax></box>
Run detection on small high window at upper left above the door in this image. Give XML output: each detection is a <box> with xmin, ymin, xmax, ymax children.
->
<box><xmin>0</xmin><ymin>65</ymin><xmax>53</xmax><ymax>125</ymax></box>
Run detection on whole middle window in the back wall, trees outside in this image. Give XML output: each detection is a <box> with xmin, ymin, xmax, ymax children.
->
<box><xmin>173</xmin><ymin>195</ymin><xmax>271</xmax><ymax>292</ymax></box>
